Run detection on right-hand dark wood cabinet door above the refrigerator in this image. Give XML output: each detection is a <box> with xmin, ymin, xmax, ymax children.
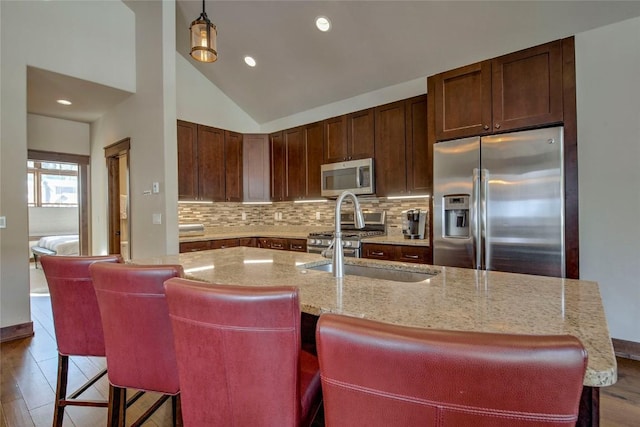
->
<box><xmin>491</xmin><ymin>40</ymin><xmax>563</xmax><ymax>131</ymax></box>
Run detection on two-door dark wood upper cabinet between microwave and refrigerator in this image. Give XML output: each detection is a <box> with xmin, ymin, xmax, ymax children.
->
<box><xmin>375</xmin><ymin>95</ymin><xmax>431</xmax><ymax>196</ymax></box>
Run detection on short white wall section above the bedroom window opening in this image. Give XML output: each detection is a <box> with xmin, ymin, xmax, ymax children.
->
<box><xmin>27</xmin><ymin>114</ymin><xmax>90</xmax><ymax>156</ymax></box>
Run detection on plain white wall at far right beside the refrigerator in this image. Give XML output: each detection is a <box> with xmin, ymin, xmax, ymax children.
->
<box><xmin>576</xmin><ymin>18</ymin><xmax>640</xmax><ymax>342</ymax></box>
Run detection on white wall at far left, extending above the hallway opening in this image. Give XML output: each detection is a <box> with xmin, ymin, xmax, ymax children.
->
<box><xmin>0</xmin><ymin>0</ymin><xmax>136</xmax><ymax>327</ymax></box>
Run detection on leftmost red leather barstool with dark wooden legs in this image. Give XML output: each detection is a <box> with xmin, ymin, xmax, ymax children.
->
<box><xmin>40</xmin><ymin>255</ymin><xmax>122</xmax><ymax>426</ymax></box>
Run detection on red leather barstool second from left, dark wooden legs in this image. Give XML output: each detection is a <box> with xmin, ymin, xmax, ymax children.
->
<box><xmin>89</xmin><ymin>264</ymin><xmax>183</xmax><ymax>426</ymax></box>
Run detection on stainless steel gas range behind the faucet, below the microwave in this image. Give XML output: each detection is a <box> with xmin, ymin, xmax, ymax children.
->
<box><xmin>307</xmin><ymin>211</ymin><xmax>386</xmax><ymax>258</ymax></box>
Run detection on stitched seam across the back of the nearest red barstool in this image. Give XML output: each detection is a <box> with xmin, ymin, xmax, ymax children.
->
<box><xmin>321</xmin><ymin>375</ymin><xmax>577</xmax><ymax>422</ymax></box>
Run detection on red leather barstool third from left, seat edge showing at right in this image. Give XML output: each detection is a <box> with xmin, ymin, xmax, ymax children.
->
<box><xmin>165</xmin><ymin>279</ymin><xmax>322</xmax><ymax>427</ymax></box>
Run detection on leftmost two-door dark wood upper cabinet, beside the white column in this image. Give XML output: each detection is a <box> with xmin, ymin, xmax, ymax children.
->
<box><xmin>177</xmin><ymin>120</ymin><xmax>242</xmax><ymax>201</ymax></box>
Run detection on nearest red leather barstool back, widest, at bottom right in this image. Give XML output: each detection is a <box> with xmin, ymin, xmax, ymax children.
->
<box><xmin>316</xmin><ymin>314</ymin><xmax>587</xmax><ymax>427</ymax></box>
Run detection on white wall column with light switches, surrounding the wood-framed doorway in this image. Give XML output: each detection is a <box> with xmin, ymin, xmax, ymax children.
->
<box><xmin>91</xmin><ymin>1</ymin><xmax>178</xmax><ymax>258</ymax></box>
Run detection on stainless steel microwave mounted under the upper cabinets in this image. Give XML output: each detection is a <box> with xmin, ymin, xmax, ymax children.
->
<box><xmin>321</xmin><ymin>159</ymin><xmax>375</xmax><ymax>197</ymax></box>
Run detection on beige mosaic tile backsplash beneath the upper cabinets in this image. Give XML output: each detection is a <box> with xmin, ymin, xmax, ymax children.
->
<box><xmin>178</xmin><ymin>198</ymin><xmax>429</xmax><ymax>234</ymax></box>
